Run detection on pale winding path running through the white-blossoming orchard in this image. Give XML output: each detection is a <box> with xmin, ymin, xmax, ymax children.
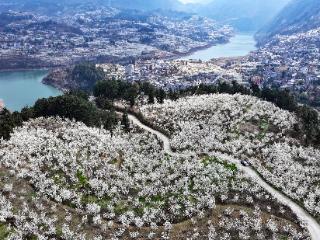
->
<box><xmin>128</xmin><ymin>114</ymin><xmax>320</xmax><ymax>240</ymax></box>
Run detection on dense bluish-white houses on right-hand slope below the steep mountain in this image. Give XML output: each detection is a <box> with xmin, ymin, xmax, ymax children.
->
<box><xmin>249</xmin><ymin>28</ymin><xmax>320</xmax><ymax>106</ymax></box>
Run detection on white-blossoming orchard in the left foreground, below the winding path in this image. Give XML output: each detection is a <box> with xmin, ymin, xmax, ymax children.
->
<box><xmin>0</xmin><ymin>118</ymin><xmax>309</xmax><ymax>239</ymax></box>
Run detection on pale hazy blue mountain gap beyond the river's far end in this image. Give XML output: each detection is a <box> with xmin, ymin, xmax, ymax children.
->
<box><xmin>189</xmin><ymin>0</ymin><xmax>289</xmax><ymax>31</ymax></box>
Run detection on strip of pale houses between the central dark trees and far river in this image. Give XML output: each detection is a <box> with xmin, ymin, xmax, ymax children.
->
<box><xmin>100</xmin><ymin>60</ymin><xmax>242</xmax><ymax>90</ymax></box>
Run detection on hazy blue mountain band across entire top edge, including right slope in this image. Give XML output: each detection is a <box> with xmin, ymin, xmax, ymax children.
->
<box><xmin>0</xmin><ymin>0</ymin><xmax>320</xmax><ymax>42</ymax></box>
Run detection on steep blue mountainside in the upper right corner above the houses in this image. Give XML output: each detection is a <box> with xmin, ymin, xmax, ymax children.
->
<box><xmin>256</xmin><ymin>0</ymin><xmax>320</xmax><ymax>43</ymax></box>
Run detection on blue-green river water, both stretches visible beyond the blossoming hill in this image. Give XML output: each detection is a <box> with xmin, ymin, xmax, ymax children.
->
<box><xmin>0</xmin><ymin>33</ymin><xmax>256</xmax><ymax>111</ymax></box>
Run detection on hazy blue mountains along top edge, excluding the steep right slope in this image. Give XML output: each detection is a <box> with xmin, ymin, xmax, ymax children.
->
<box><xmin>0</xmin><ymin>0</ymin><xmax>289</xmax><ymax>31</ymax></box>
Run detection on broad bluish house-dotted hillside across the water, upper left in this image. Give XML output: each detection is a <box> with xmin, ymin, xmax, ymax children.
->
<box><xmin>0</xmin><ymin>8</ymin><xmax>233</xmax><ymax>68</ymax></box>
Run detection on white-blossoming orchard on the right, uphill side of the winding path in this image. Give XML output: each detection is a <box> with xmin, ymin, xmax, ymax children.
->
<box><xmin>141</xmin><ymin>94</ymin><xmax>320</xmax><ymax>221</ymax></box>
